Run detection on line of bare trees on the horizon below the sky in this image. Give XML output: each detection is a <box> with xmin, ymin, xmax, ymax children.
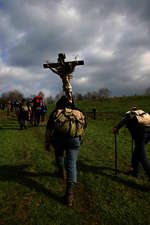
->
<box><xmin>0</xmin><ymin>87</ymin><xmax>150</xmax><ymax>104</ymax></box>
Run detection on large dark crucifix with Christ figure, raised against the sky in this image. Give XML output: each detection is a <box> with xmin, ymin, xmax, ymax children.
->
<box><xmin>43</xmin><ymin>53</ymin><xmax>84</xmax><ymax>102</ymax></box>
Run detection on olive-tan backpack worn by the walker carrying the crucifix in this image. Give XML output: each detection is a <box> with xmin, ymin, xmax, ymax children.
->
<box><xmin>53</xmin><ymin>108</ymin><xmax>85</xmax><ymax>137</ymax></box>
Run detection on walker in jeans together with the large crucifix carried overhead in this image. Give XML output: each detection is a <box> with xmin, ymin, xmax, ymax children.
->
<box><xmin>43</xmin><ymin>53</ymin><xmax>86</xmax><ymax>207</ymax></box>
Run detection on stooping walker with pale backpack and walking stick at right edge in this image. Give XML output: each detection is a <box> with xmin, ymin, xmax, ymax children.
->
<box><xmin>113</xmin><ymin>107</ymin><xmax>150</xmax><ymax>178</ymax></box>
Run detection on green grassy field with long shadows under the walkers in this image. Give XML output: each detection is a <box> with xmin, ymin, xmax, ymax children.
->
<box><xmin>0</xmin><ymin>96</ymin><xmax>150</xmax><ymax>225</ymax></box>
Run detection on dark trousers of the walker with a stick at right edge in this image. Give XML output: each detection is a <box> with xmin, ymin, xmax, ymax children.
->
<box><xmin>132</xmin><ymin>133</ymin><xmax>150</xmax><ymax>178</ymax></box>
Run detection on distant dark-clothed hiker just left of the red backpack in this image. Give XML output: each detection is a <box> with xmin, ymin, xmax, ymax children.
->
<box><xmin>18</xmin><ymin>99</ymin><xmax>28</xmax><ymax>130</ymax></box>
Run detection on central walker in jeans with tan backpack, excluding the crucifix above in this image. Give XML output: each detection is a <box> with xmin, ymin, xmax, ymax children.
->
<box><xmin>46</xmin><ymin>96</ymin><xmax>86</xmax><ymax>207</ymax></box>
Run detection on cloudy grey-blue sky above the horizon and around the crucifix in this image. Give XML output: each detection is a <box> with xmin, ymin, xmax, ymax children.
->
<box><xmin>0</xmin><ymin>0</ymin><xmax>150</xmax><ymax>96</ymax></box>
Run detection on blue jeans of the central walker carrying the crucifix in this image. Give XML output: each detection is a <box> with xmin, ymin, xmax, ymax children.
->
<box><xmin>54</xmin><ymin>136</ymin><xmax>80</xmax><ymax>183</ymax></box>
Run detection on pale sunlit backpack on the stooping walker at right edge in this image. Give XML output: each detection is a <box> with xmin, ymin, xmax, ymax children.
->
<box><xmin>130</xmin><ymin>110</ymin><xmax>150</xmax><ymax>127</ymax></box>
